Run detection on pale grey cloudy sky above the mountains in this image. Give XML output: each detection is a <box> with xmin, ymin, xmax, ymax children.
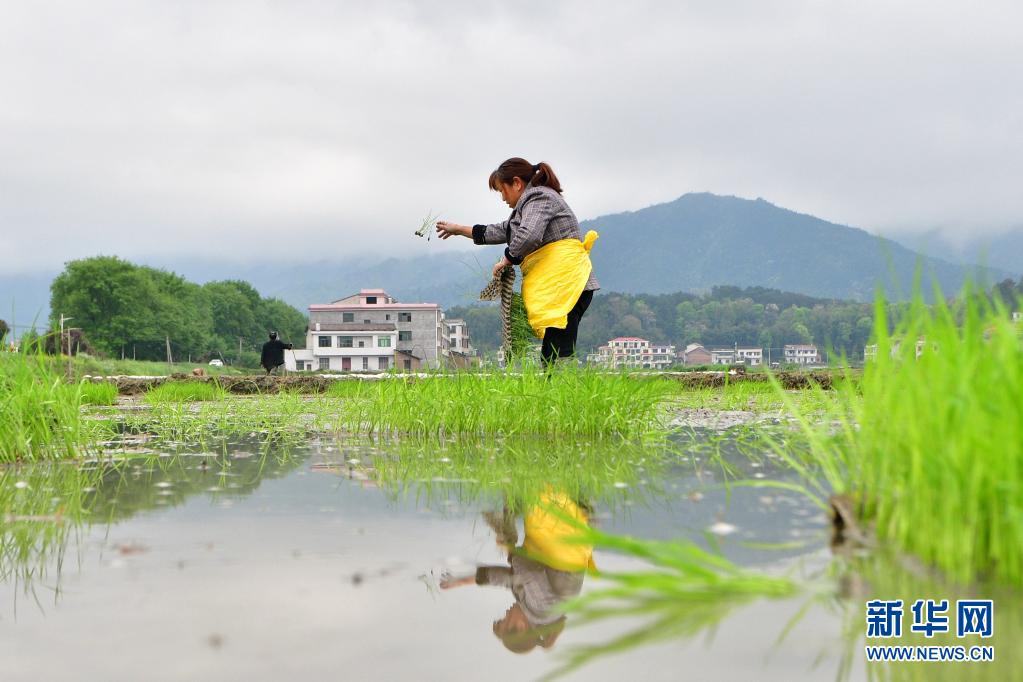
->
<box><xmin>0</xmin><ymin>0</ymin><xmax>1023</xmax><ymax>273</ymax></box>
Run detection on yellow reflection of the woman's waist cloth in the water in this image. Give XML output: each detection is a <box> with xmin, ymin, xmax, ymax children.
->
<box><xmin>523</xmin><ymin>490</ymin><xmax>596</xmax><ymax>572</ymax></box>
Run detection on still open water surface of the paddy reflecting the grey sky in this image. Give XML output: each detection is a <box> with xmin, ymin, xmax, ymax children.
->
<box><xmin>0</xmin><ymin>441</ymin><xmax>840</xmax><ymax>680</ymax></box>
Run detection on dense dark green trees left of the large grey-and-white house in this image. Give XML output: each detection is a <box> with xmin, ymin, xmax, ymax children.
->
<box><xmin>42</xmin><ymin>256</ymin><xmax>307</xmax><ymax>366</ymax></box>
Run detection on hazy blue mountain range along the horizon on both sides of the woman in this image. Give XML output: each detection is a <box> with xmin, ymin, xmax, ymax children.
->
<box><xmin>0</xmin><ymin>193</ymin><xmax>1006</xmax><ymax>337</ymax></box>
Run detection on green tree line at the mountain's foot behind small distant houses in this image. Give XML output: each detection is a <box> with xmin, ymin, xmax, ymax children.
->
<box><xmin>447</xmin><ymin>278</ymin><xmax>1023</xmax><ymax>359</ymax></box>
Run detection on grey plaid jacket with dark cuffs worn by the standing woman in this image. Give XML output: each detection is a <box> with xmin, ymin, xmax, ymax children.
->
<box><xmin>473</xmin><ymin>187</ymin><xmax>601</xmax><ymax>291</ymax></box>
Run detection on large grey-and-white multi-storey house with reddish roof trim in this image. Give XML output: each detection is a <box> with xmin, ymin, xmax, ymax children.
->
<box><xmin>284</xmin><ymin>289</ymin><xmax>472</xmax><ymax>371</ymax></box>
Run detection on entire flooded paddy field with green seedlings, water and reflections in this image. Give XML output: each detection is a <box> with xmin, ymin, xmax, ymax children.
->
<box><xmin>0</xmin><ymin>302</ymin><xmax>1023</xmax><ymax>680</ymax></box>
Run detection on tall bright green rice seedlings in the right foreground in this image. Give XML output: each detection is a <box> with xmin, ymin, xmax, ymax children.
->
<box><xmin>775</xmin><ymin>287</ymin><xmax>1023</xmax><ymax>585</ymax></box>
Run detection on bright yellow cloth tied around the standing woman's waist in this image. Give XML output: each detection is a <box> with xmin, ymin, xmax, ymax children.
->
<box><xmin>521</xmin><ymin>230</ymin><xmax>599</xmax><ymax>338</ymax></box>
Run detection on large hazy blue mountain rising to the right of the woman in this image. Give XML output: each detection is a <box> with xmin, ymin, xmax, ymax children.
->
<box><xmin>583</xmin><ymin>193</ymin><xmax>1009</xmax><ymax>301</ymax></box>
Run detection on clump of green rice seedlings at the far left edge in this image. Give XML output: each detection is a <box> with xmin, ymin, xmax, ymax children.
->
<box><xmin>0</xmin><ymin>353</ymin><xmax>112</xmax><ymax>462</ymax></box>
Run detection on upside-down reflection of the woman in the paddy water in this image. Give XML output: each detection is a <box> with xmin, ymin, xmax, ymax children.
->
<box><xmin>441</xmin><ymin>492</ymin><xmax>595</xmax><ymax>653</ymax></box>
